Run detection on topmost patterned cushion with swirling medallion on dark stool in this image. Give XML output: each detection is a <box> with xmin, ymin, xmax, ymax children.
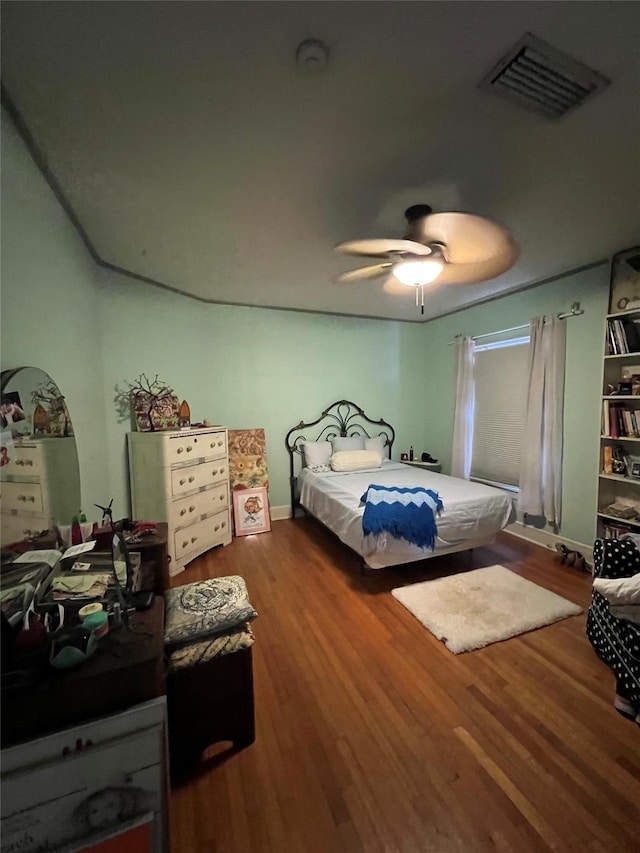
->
<box><xmin>164</xmin><ymin>575</ymin><xmax>258</xmax><ymax>646</ymax></box>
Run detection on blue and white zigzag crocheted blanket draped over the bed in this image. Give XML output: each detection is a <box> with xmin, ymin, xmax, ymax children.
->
<box><xmin>360</xmin><ymin>485</ymin><xmax>443</xmax><ymax>551</ymax></box>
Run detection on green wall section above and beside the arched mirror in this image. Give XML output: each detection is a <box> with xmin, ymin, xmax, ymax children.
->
<box><xmin>0</xmin><ymin>111</ymin><xmax>108</xmax><ymax>513</ymax></box>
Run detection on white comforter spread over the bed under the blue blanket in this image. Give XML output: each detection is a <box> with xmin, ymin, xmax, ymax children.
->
<box><xmin>299</xmin><ymin>461</ymin><xmax>515</xmax><ymax>568</ymax></box>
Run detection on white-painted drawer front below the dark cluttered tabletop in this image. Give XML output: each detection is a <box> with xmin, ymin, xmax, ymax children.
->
<box><xmin>1</xmin><ymin>697</ymin><xmax>169</xmax><ymax>853</ymax></box>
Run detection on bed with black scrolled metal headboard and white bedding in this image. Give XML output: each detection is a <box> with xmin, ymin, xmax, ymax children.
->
<box><xmin>285</xmin><ymin>400</ymin><xmax>515</xmax><ymax>569</ymax></box>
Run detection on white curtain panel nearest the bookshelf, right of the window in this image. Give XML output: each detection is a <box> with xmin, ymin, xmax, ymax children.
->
<box><xmin>518</xmin><ymin>317</ymin><xmax>566</xmax><ymax>527</ymax></box>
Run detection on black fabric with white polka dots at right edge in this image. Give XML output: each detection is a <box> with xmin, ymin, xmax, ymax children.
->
<box><xmin>587</xmin><ymin>539</ymin><xmax>640</xmax><ymax>723</ymax></box>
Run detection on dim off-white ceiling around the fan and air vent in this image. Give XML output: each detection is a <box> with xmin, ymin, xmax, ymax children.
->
<box><xmin>2</xmin><ymin>0</ymin><xmax>640</xmax><ymax>322</ymax></box>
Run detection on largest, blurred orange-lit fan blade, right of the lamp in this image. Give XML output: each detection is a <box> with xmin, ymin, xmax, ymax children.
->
<box><xmin>410</xmin><ymin>213</ymin><xmax>518</xmax><ymax>264</ymax></box>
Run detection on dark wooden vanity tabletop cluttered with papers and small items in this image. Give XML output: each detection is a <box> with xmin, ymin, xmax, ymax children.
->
<box><xmin>1</xmin><ymin>524</ymin><xmax>168</xmax><ymax>748</ymax></box>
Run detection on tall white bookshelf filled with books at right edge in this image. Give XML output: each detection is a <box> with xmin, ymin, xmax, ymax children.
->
<box><xmin>596</xmin><ymin>308</ymin><xmax>640</xmax><ymax>538</ymax></box>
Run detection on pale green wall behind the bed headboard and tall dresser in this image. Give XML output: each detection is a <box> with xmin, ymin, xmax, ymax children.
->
<box><xmin>92</xmin><ymin>274</ymin><xmax>426</xmax><ymax>506</ymax></box>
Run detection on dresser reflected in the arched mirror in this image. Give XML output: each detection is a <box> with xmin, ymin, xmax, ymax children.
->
<box><xmin>0</xmin><ymin>436</ymin><xmax>80</xmax><ymax>544</ymax></box>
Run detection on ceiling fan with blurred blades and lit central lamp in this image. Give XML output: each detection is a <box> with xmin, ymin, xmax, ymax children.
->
<box><xmin>336</xmin><ymin>204</ymin><xmax>520</xmax><ymax>313</ymax></box>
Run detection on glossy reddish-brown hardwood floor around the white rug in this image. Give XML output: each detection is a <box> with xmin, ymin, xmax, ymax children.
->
<box><xmin>171</xmin><ymin>519</ymin><xmax>640</xmax><ymax>853</ymax></box>
